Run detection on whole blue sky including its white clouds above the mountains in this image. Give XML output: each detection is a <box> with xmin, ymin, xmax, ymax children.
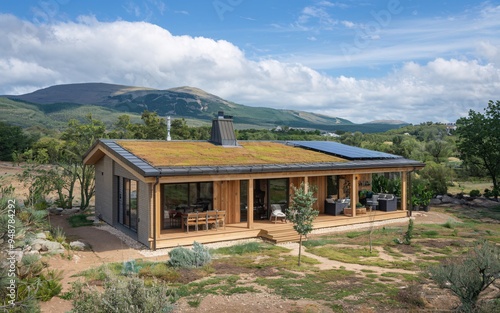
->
<box><xmin>0</xmin><ymin>0</ymin><xmax>500</xmax><ymax>123</ymax></box>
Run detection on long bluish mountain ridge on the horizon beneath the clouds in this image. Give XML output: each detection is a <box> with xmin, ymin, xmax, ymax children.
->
<box><xmin>3</xmin><ymin>82</ymin><xmax>407</xmax><ymax>132</ymax></box>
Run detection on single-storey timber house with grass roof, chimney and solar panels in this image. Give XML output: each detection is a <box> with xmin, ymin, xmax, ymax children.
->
<box><xmin>84</xmin><ymin>115</ymin><xmax>424</xmax><ymax>249</ymax></box>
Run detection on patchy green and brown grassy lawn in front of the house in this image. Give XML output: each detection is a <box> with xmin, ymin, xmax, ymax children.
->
<box><xmin>67</xmin><ymin>208</ymin><xmax>500</xmax><ymax>312</ymax></box>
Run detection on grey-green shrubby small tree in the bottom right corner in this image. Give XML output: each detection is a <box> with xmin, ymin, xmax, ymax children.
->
<box><xmin>429</xmin><ymin>240</ymin><xmax>500</xmax><ymax>312</ymax></box>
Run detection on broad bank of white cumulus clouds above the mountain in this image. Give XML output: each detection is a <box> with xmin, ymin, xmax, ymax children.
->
<box><xmin>0</xmin><ymin>15</ymin><xmax>500</xmax><ymax>123</ymax></box>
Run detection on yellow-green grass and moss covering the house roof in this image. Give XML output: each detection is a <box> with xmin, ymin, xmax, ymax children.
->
<box><xmin>117</xmin><ymin>140</ymin><xmax>345</xmax><ymax>167</ymax></box>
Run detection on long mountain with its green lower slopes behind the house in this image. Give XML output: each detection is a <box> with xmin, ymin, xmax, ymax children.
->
<box><xmin>0</xmin><ymin>83</ymin><xmax>406</xmax><ymax>132</ymax></box>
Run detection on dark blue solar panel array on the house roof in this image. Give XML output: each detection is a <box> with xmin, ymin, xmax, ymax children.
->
<box><xmin>287</xmin><ymin>141</ymin><xmax>402</xmax><ymax>160</ymax></box>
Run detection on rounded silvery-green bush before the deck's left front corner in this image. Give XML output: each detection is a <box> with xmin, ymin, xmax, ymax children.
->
<box><xmin>168</xmin><ymin>241</ymin><xmax>212</xmax><ymax>268</ymax></box>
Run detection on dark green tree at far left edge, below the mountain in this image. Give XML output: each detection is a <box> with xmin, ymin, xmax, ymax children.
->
<box><xmin>0</xmin><ymin>122</ymin><xmax>36</xmax><ymax>161</ymax></box>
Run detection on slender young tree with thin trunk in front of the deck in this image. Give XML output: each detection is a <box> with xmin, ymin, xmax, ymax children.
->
<box><xmin>286</xmin><ymin>183</ymin><xmax>319</xmax><ymax>266</ymax></box>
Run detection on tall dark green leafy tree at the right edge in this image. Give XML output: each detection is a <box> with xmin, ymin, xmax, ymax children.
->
<box><xmin>456</xmin><ymin>101</ymin><xmax>500</xmax><ymax>199</ymax></box>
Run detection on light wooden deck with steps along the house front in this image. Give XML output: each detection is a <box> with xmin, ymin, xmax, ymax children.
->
<box><xmin>156</xmin><ymin>211</ymin><xmax>407</xmax><ymax>249</ymax></box>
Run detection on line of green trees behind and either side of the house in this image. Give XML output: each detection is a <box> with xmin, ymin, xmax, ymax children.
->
<box><xmin>0</xmin><ymin>101</ymin><xmax>500</xmax><ymax>210</ymax></box>
